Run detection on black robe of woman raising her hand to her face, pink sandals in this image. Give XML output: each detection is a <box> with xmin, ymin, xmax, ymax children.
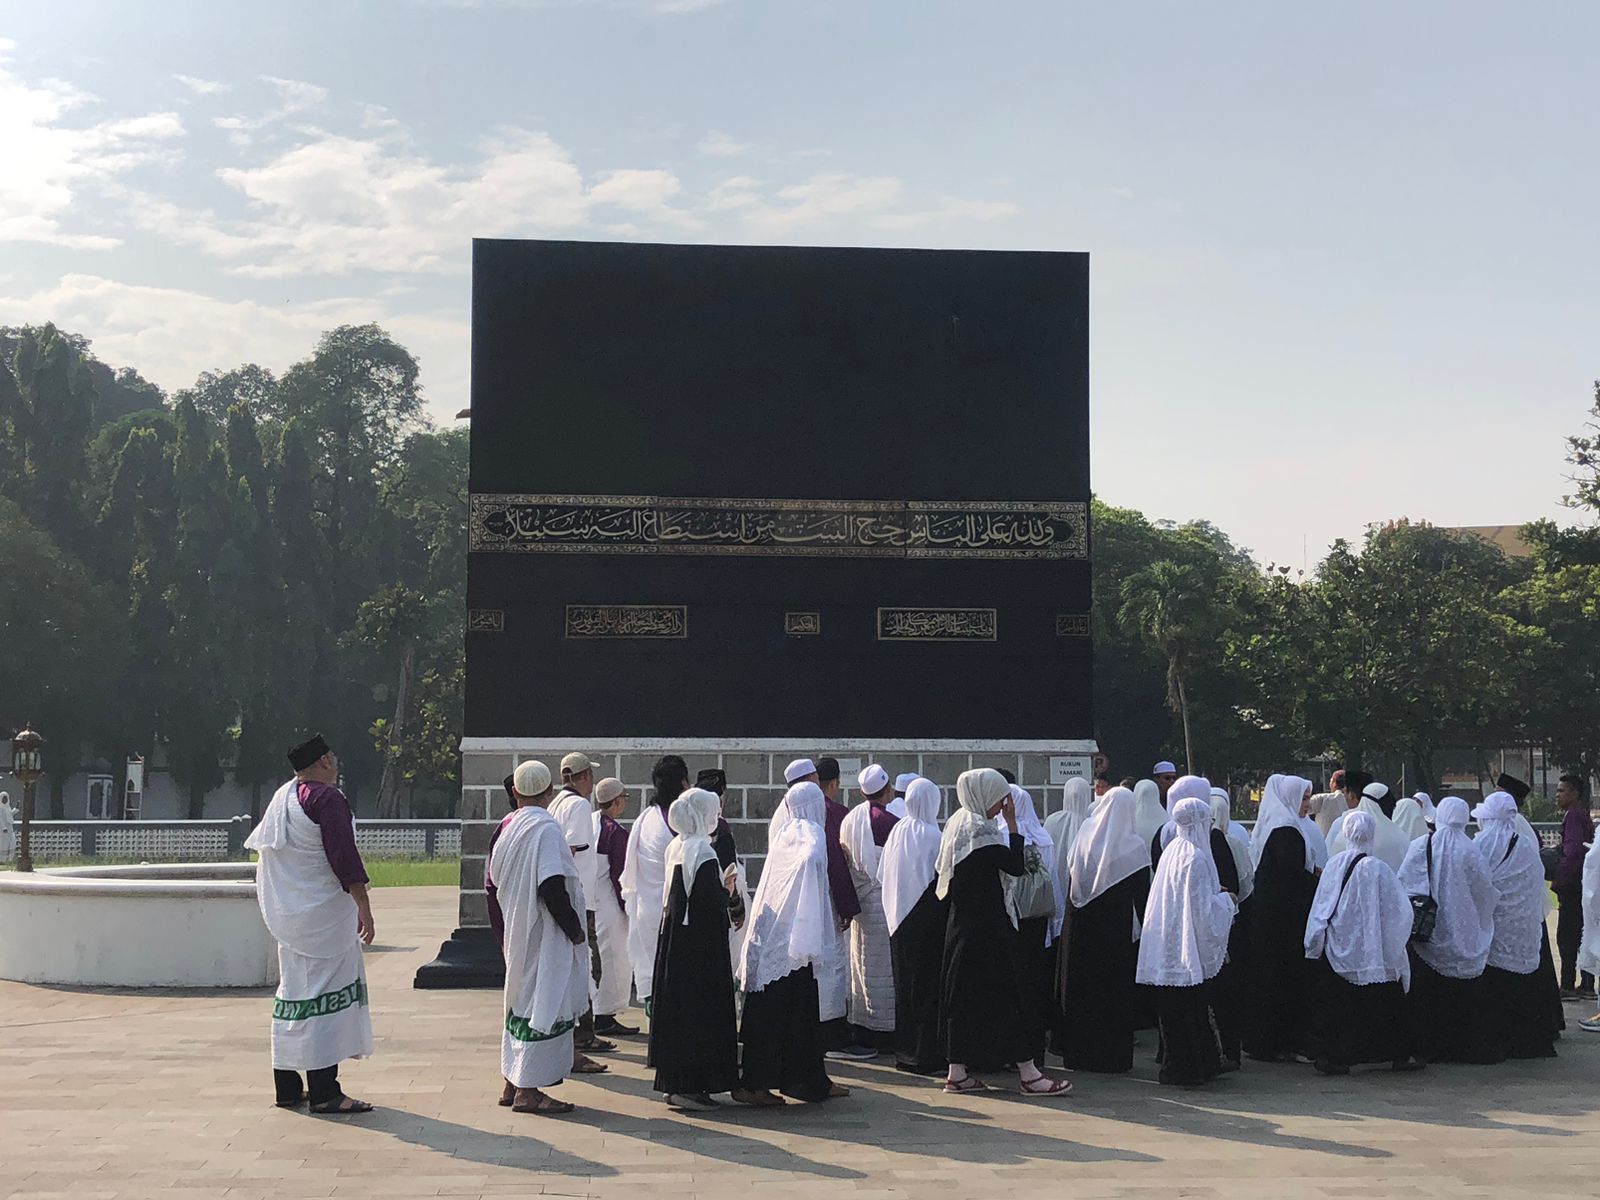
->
<box><xmin>939</xmin><ymin>834</ymin><xmax>1038</xmax><ymax>1069</ymax></box>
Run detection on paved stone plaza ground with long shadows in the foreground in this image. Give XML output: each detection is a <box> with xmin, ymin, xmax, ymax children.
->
<box><xmin>0</xmin><ymin>888</ymin><xmax>1600</xmax><ymax>1200</ymax></box>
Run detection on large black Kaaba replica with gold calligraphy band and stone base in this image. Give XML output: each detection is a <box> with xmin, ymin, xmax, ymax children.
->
<box><xmin>418</xmin><ymin>240</ymin><xmax>1094</xmax><ymax>986</ymax></box>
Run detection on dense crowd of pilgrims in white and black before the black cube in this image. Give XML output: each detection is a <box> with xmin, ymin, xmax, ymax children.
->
<box><xmin>485</xmin><ymin>754</ymin><xmax>1592</xmax><ymax>1114</ymax></box>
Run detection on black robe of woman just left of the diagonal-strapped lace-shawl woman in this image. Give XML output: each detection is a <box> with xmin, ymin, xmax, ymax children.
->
<box><xmin>1243</xmin><ymin>826</ymin><xmax>1317</xmax><ymax>1062</ymax></box>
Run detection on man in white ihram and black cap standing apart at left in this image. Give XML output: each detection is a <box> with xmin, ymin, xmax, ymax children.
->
<box><xmin>245</xmin><ymin>734</ymin><xmax>373</xmax><ymax>1114</ymax></box>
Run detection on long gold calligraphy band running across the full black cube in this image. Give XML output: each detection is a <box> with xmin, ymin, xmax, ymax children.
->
<box><xmin>467</xmin><ymin>494</ymin><xmax>1088</xmax><ymax>560</ymax></box>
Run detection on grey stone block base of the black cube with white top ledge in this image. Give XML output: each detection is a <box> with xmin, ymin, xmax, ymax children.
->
<box><xmin>461</xmin><ymin>738</ymin><xmax>1096</xmax><ymax>926</ymax></box>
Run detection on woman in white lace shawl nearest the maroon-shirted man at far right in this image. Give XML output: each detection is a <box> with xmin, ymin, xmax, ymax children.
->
<box><xmin>1472</xmin><ymin>792</ymin><xmax>1560</xmax><ymax>1058</ymax></box>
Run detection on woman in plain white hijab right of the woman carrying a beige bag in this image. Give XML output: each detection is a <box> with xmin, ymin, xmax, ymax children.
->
<box><xmin>1059</xmin><ymin>787</ymin><xmax>1150</xmax><ymax>1074</ymax></box>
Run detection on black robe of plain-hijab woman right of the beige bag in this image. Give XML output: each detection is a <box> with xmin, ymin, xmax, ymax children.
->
<box><xmin>1056</xmin><ymin>869</ymin><xmax>1154</xmax><ymax>1074</ymax></box>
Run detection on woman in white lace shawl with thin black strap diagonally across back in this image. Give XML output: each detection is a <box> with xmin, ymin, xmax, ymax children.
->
<box><xmin>1306</xmin><ymin>813</ymin><xmax>1422</xmax><ymax>1075</ymax></box>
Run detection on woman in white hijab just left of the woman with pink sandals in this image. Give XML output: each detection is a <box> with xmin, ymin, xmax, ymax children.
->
<box><xmin>878</xmin><ymin>779</ymin><xmax>947</xmax><ymax>1075</ymax></box>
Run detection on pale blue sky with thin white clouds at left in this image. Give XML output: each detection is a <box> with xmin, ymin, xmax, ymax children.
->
<box><xmin>0</xmin><ymin>0</ymin><xmax>1600</xmax><ymax>566</ymax></box>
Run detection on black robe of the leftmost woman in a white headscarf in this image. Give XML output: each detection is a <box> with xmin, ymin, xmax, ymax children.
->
<box><xmin>646</xmin><ymin>861</ymin><xmax>739</xmax><ymax>1096</ymax></box>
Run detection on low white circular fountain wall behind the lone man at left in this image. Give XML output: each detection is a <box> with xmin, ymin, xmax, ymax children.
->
<box><xmin>0</xmin><ymin>862</ymin><xmax>278</xmax><ymax>987</ymax></box>
